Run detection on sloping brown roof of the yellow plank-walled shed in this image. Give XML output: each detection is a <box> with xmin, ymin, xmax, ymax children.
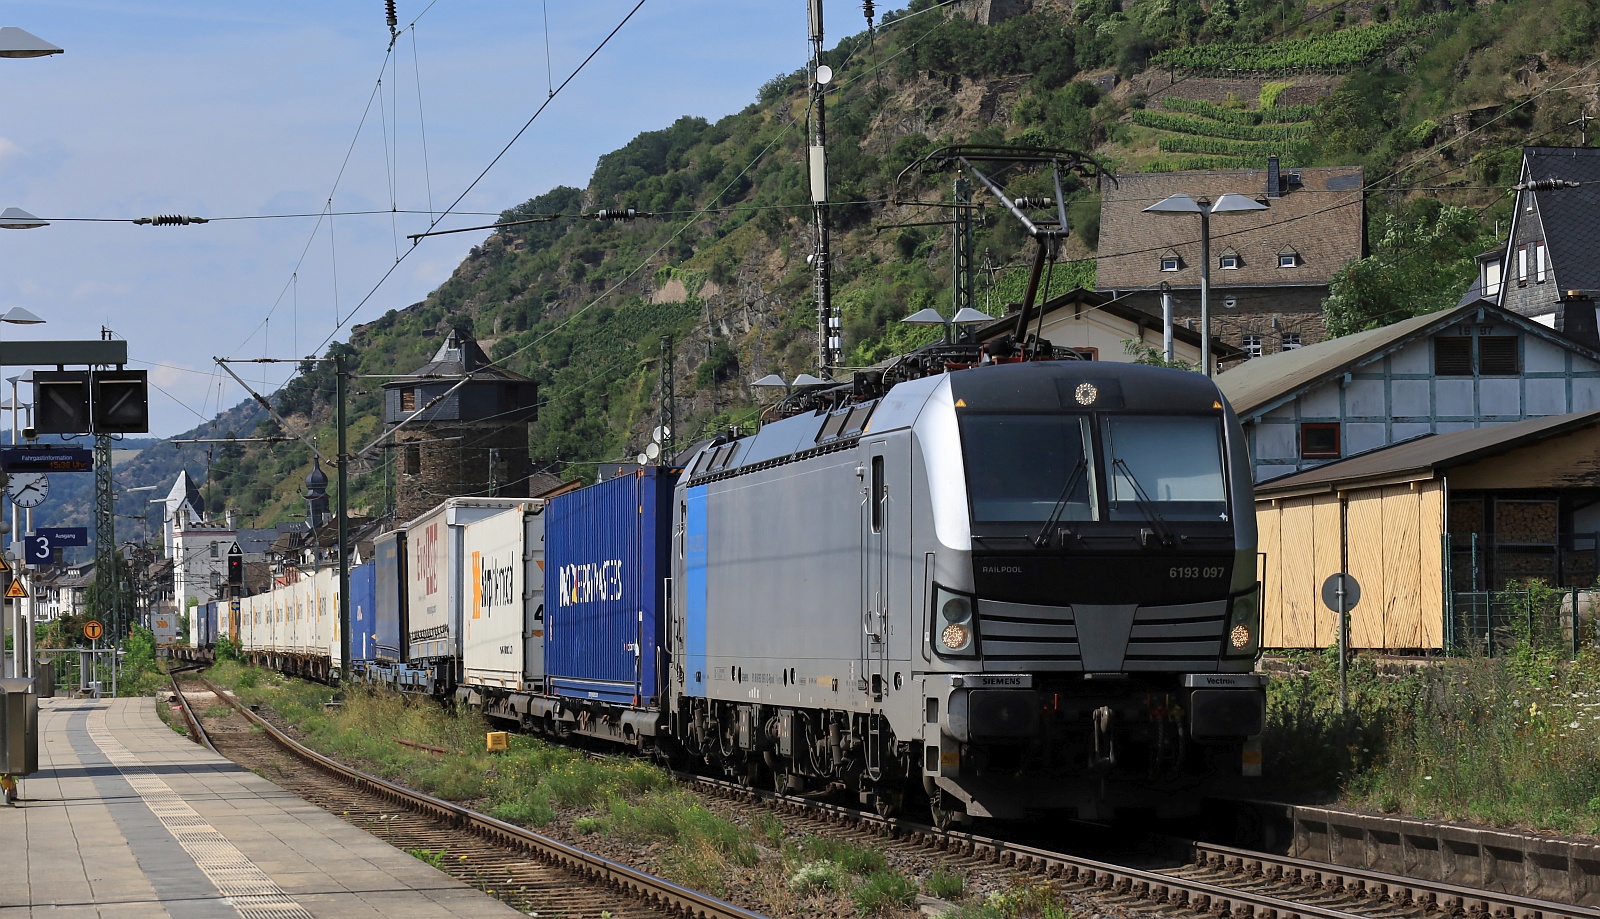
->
<box><xmin>1256</xmin><ymin>408</ymin><xmax>1600</xmax><ymax>500</ymax></box>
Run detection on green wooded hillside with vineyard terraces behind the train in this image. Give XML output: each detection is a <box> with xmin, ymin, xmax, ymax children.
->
<box><xmin>156</xmin><ymin>0</ymin><xmax>1600</xmax><ymax>525</ymax></box>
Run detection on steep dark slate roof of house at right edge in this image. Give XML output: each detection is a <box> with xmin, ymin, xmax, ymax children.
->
<box><xmin>1517</xmin><ymin>147</ymin><xmax>1600</xmax><ymax>296</ymax></box>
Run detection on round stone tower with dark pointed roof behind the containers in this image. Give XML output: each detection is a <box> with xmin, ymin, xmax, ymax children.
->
<box><xmin>384</xmin><ymin>330</ymin><xmax>539</xmax><ymax>520</ymax></box>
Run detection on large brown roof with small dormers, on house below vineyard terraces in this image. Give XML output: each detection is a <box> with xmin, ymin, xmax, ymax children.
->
<box><xmin>1094</xmin><ymin>167</ymin><xmax>1365</xmax><ymax>290</ymax></box>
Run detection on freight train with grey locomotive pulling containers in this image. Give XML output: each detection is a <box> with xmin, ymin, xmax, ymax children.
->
<box><xmin>190</xmin><ymin>360</ymin><xmax>1266</xmax><ymax>825</ymax></box>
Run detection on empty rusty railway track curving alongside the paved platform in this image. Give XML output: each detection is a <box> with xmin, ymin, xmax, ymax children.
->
<box><xmin>173</xmin><ymin>671</ymin><xmax>762</xmax><ymax>919</ymax></box>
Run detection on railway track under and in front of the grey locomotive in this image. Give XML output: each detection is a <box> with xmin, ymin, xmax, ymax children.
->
<box><xmin>693</xmin><ymin>777</ymin><xmax>1600</xmax><ymax>919</ymax></box>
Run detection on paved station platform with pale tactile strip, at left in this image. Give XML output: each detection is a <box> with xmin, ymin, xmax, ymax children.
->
<box><xmin>0</xmin><ymin>698</ymin><xmax>520</xmax><ymax>919</ymax></box>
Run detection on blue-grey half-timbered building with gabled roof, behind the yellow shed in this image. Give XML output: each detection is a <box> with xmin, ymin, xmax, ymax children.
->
<box><xmin>1216</xmin><ymin>299</ymin><xmax>1600</xmax><ymax>482</ymax></box>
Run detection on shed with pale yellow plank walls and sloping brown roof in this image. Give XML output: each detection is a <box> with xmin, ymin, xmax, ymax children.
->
<box><xmin>1256</xmin><ymin>410</ymin><xmax>1600</xmax><ymax>652</ymax></box>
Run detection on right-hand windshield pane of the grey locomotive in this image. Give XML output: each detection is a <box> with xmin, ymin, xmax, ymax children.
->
<box><xmin>1104</xmin><ymin>415</ymin><xmax>1227</xmax><ymax>520</ymax></box>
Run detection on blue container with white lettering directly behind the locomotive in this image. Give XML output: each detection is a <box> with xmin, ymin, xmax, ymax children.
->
<box><xmin>544</xmin><ymin>466</ymin><xmax>678</xmax><ymax>706</ymax></box>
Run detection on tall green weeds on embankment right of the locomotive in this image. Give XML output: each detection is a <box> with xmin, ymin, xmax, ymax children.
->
<box><xmin>1266</xmin><ymin>595</ymin><xmax>1600</xmax><ymax>836</ymax></box>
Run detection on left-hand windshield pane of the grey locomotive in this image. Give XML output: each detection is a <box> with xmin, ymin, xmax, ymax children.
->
<box><xmin>962</xmin><ymin>415</ymin><xmax>1096</xmax><ymax>524</ymax></box>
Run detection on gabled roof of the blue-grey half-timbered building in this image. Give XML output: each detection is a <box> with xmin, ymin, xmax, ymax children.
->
<box><xmin>1216</xmin><ymin>301</ymin><xmax>1600</xmax><ymax>419</ymax></box>
